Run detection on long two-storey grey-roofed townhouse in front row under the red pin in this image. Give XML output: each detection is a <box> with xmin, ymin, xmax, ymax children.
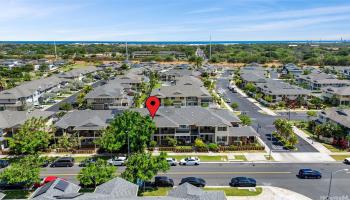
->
<box><xmin>55</xmin><ymin>107</ymin><xmax>258</xmax><ymax>147</ymax></box>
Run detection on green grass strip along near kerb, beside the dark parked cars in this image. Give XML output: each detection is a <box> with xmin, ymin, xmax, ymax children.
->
<box><xmin>143</xmin><ymin>187</ymin><xmax>262</xmax><ymax>196</ymax></box>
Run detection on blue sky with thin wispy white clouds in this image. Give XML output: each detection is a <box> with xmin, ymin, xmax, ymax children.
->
<box><xmin>0</xmin><ymin>0</ymin><xmax>350</xmax><ymax>41</ymax></box>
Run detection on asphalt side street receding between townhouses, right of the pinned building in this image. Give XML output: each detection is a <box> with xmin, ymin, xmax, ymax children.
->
<box><xmin>216</xmin><ymin>72</ymin><xmax>317</xmax><ymax>152</ymax></box>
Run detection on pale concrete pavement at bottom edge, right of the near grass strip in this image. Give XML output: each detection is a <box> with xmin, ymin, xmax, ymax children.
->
<box><xmin>227</xmin><ymin>186</ymin><xmax>311</xmax><ymax>200</ymax></box>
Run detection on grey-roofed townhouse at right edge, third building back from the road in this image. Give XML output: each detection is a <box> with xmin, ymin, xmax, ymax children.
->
<box><xmin>296</xmin><ymin>72</ymin><xmax>350</xmax><ymax>90</ymax></box>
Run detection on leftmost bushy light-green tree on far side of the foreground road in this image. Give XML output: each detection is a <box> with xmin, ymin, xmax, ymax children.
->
<box><xmin>8</xmin><ymin>118</ymin><xmax>54</xmax><ymax>154</ymax></box>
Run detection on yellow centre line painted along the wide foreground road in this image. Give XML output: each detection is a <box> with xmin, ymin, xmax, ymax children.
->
<box><xmin>40</xmin><ymin>172</ymin><xmax>292</xmax><ymax>176</ymax></box>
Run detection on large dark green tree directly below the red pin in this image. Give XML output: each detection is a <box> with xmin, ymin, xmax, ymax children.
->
<box><xmin>98</xmin><ymin>111</ymin><xmax>156</xmax><ymax>152</ymax></box>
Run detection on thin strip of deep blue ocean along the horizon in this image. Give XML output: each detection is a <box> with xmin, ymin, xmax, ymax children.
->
<box><xmin>0</xmin><ymin>40</ymin><xmax>348</xmax><ymax>45</ymax></box>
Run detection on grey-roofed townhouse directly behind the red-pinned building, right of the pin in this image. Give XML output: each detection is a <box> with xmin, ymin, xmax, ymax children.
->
<box><xmin>151</xmin><ymin>76</ymin><xmax>213</xmax><ymax>107</ymax></box>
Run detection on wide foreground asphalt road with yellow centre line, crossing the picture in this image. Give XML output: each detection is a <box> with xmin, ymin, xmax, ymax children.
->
<box><xmin>41</xmin><ymin>163</ymin><xmax>350</xmax><ymax>199</ymax></box>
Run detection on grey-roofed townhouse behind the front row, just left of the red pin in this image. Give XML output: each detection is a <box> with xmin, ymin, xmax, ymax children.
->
<box><xmin>85</xmin><ymin>81</ymin><xmax>132</xmax><ymax>110</ymax></box>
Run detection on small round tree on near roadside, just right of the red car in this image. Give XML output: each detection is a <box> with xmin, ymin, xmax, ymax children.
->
<box><xmin>78</xmin><ymin>159</ymin><xmax>116</xmax><ymax>187</ymax></box>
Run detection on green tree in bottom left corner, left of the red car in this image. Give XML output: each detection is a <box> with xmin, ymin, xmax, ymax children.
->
<box><xmin>0</xmin><ymin>156</ymin><xmax>40</xmax><ymax>188</ymax></box>
